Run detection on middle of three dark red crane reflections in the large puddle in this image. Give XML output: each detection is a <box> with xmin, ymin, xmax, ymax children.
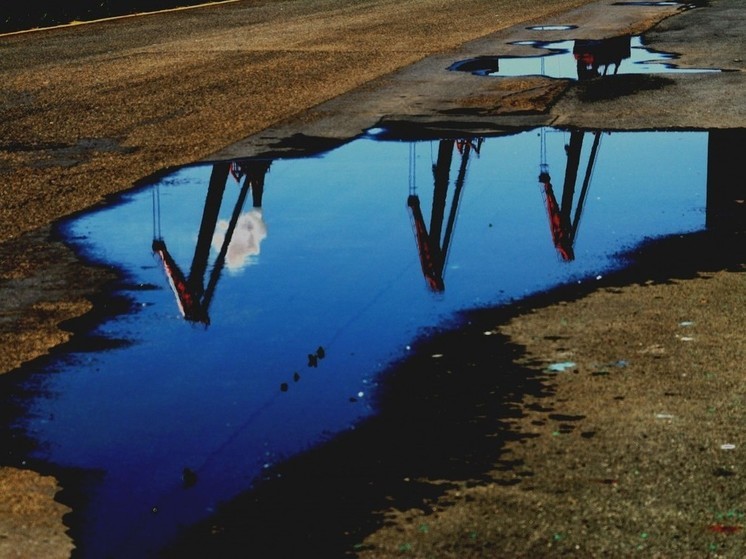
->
<box><xmin>407</xmin><ymin>138</ymin><xmax>483</xmax><ymax>292</ymax></box>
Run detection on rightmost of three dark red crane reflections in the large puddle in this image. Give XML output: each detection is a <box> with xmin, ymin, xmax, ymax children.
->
<box><xmin>539</xmin><ymin>128</ymin><xmax>601</xmax><ymax>262</ymax></box>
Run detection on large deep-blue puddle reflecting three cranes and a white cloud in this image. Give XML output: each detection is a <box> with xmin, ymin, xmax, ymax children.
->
<box><xmin>8</xmin><ymin>128</ymin><xmax>730</xmax><ymax>557</ymax></box>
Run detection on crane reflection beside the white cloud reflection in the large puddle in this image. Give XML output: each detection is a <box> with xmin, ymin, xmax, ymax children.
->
<box><xmin>152</xmin><ymin>161</ymin><xmax>271</xmax><ymax>325</ymax></box>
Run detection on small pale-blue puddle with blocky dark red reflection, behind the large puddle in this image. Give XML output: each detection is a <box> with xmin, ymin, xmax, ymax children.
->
<box><xmin>448</xmin><ymin>36</ymin><xmax>721</xmax><ymax>80</ymax></box>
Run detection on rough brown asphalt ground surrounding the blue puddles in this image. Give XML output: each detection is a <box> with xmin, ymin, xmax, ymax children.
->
<box><xmin>0</xmin><ymin>0</ymin><xmax>746</xmax><ymax>557</ymax></box>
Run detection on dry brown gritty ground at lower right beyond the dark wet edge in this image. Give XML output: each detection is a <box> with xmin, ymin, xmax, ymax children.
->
<box><xmin>360</xmin><ymin>260</ymin><xmax>746</xmax><ymax>558</ymax></box>
